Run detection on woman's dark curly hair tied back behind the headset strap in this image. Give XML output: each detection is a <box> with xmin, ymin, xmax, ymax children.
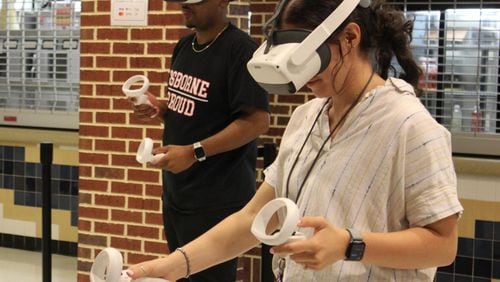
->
<box><xmin>278</xmin><ymin>0</ymin><xmax>422</xmax><ymax>88</ymax></box>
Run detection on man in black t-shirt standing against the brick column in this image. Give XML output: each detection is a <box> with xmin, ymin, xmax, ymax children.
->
<box><xmin>130</xmin><ymin>0</ymin><xmax>269</xmax><ymax>282</ymax></box>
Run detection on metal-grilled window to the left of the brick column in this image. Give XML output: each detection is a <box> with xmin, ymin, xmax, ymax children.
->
<box><xmin>0</xmin><ymin>0</ymin><xmax>81</xmax><ymax>129</ymax></box>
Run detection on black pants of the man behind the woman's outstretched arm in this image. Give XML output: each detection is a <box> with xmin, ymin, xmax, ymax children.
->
<box><xmin>163</xmin><ymin>206</ymin><xmax>241</xmax><ymax>282</ymax></box>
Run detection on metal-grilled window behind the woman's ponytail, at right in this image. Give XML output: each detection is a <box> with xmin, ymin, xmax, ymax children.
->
<box><xmin>392</xmin><ymin>0</ymin><xmax>500</xmax><ymax>156</ymax></box>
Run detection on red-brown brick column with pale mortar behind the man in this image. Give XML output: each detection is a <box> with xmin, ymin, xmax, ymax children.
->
<box><xmin>78</xmin><ymin>0</ymin><xmax>307</xmax><ymax>281</ymax></box>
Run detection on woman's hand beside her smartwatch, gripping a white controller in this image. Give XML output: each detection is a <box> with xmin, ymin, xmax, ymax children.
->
<box><xmin>271</xmin><ymin>217</ymin><xmax>350</xmax><ymax>270</ymax></box>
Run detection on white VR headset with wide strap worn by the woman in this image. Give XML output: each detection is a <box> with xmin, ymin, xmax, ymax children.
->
<box><xmin>247</xmin><ymin>0</ymin><xmax>371</xmax><ymax>94</ymax></box>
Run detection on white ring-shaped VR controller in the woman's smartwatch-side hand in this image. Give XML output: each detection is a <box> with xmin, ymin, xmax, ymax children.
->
<box><xmin>251</xmin><ymin>198</ymin><xmax>306</xmax><ymax>246</ymax></box>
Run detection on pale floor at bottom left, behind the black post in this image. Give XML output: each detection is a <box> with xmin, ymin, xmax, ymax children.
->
<box><xmin>0</xmin><ymin>248</ymin><xmax>77</xmax><ymax>282</ymax></box>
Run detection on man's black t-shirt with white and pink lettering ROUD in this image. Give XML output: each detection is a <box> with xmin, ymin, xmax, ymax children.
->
<box><xmin>163</xmin><ymin>24</ymin><xmax>268</xmax><ymax>212</ymax></box>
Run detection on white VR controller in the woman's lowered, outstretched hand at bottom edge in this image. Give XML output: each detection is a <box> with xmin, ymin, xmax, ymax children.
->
<box><xmin>90</xmin><ymin>248</ymin><xmax>168</xmax><ymax>282</ymax></box>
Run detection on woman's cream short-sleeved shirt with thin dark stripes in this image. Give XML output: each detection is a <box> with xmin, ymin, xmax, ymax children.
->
<box><xmin>265</xmin><ymin>78</ymin><xmax>463</xmax><ymax>281</ymax></box>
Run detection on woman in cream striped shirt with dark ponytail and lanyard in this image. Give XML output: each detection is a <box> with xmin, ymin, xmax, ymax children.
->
<box><xmin>128</xmin><ymin>0</ymin><xmax>463</xmax><ymax>281</ymax></box>
